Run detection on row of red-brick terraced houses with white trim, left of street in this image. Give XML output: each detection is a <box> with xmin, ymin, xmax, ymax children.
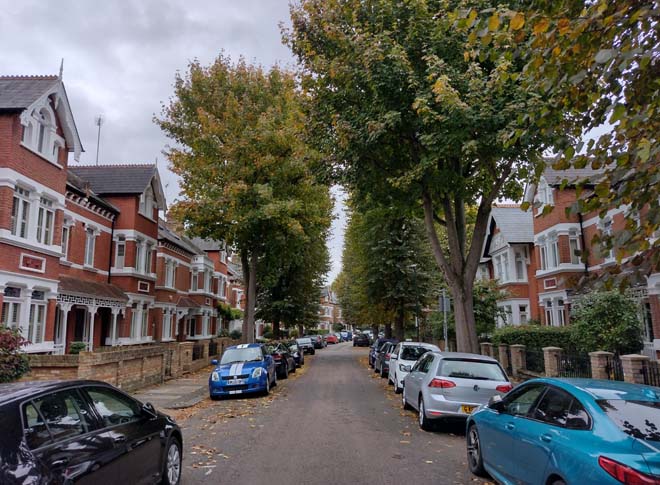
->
<box><xmin>0</xmin><ymin>76</ymin><xmax>242</xmax><ymax>360</ymax></box>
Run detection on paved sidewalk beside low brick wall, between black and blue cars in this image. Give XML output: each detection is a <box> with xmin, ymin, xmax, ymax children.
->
<box><xmin>131</xmin><ymin>366</ymin><xmax>213</xmax><ymax>409</ymax></box>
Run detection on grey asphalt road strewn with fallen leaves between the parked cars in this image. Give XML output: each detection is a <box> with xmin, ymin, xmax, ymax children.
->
<box><xmin>182</xmin><ymin>343</ymin><xmax>488</xmax><ymax>485</ymax></box>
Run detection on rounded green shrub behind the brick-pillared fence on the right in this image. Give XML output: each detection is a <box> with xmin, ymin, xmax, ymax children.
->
<box><xmin>570</xmin><ymin>291</ymin><xmax>644</xmax><ymax>354</ymax></box>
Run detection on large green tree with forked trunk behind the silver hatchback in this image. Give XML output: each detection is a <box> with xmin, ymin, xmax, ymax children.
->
<box><xmin>284</xmin><ymin>0</ymin><xmax>558</xmax><ymax>352</ymax></box>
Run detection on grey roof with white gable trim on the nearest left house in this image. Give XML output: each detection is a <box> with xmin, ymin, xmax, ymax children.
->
<box><xmin>0</xmin><ymin>76</ymin><xmax>84</xmax><ymax>161</ymax></box>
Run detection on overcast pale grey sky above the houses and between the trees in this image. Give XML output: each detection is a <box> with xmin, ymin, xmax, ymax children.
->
<box><xmin>0</xmin><ymin>0</ymin><xmax>345</xmax><ymax>282</ymax></box>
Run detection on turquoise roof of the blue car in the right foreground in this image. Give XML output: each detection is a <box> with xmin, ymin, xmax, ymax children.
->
<box><xmin>528</xmin><ymin>377</ymin><xmax>660</xmax><ymax>401</ymax></box>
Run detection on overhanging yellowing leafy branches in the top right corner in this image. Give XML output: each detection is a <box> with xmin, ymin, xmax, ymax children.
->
<box><xmin>462</xmin><ymin>0</ymin><xmax>660</xmax><ymax>271</ymax></box>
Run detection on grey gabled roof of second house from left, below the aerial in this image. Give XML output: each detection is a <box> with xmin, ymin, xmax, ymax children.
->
<box><xmin>69</xmin><ymin>164</ymin><xmax>165</xmax><ymax>210</ymax></box>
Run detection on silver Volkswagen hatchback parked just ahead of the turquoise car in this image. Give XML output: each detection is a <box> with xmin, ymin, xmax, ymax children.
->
<box><xmin>402</xmin><ymin>352</ymin><xmax>512</xmax><ymax>430</ymax></box>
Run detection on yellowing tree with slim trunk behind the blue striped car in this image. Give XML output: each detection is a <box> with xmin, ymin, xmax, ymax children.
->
<box><xmin>155</xmin><ymin>54</ymin><xmax>328</xmax><ymax>342</ymax></box>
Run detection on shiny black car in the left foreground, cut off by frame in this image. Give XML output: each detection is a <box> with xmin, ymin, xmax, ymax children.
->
<box><xmin>0</xmin><ymin>381</ymin><xmax>183</xmax><ymax>485</ymax></box>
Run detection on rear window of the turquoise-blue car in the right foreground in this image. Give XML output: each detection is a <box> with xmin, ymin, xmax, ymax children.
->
<box><xmin>597</xmin><ymin>399</ymin><xmax>660</xmax><ymax>442</ymax></box>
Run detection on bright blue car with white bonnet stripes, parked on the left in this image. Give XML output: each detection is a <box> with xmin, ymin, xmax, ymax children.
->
<box><xmin>209</xmin><ymin>344</ymin><xmax>277</xmax><ymax>399</ymax></box>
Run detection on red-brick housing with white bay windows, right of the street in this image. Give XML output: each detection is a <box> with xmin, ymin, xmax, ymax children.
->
<box><xmin>478</xmin><ymin>168</ymin><xmax>660</xmax><ymax>357</ymax></box>
